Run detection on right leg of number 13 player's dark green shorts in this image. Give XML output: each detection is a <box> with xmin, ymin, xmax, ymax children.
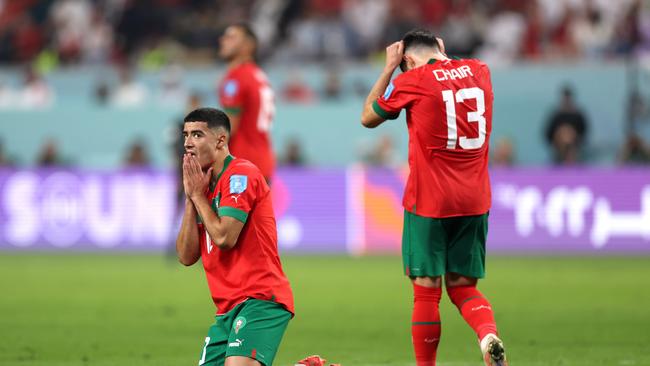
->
<box><xmin>446</xmin><ymin>213</ymin><xmax>488</xmax><ymax>278</ymax></box>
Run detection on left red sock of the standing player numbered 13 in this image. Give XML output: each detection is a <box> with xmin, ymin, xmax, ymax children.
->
<box><xmin>411</xmin><ymin>284</ymin><xmax>442</xmax><ymax>366</ymax></box>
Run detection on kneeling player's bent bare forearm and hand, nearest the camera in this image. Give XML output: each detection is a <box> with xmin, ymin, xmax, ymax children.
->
<box><xmin>183</xmin><ymin>155</ymin><xmax>244</xmax><ymax>249</ymax></box>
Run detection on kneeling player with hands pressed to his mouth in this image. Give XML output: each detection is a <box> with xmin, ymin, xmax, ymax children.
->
<box><xmin>176</xmin><ymin>108</ymin><xmax>294</xmax><ymax>366</ymax></box>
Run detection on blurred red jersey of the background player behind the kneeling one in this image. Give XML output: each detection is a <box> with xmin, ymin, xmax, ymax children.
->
<box><xmin>219</xmin><ymin>62</ymin><xmax>275</xmax><ymax>179</ymax></box>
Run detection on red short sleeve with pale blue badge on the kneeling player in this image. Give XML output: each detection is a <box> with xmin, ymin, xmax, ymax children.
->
<box><xmin>218</xmin><ymin>168</ymin><xmax>257</xmax><ymax>223</ymax></box>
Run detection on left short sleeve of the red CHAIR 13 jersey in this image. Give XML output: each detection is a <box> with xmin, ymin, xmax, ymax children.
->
<box><xmin>372</xmin><ymin>73</ymin><xmax>417</xmax><ymax>119</ymax></box>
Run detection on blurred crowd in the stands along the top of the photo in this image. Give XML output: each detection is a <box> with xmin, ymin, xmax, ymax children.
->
<box><xmin>0</xmin><ymin>0</ymin><xmax>650</xmax><ymax>67</ymax></box>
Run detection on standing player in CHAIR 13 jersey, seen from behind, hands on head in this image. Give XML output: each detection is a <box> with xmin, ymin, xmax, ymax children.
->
<box><xmin>361</xmin><ymin>30</ymin><xmax>507</xmax><ymax>366</ymax></box>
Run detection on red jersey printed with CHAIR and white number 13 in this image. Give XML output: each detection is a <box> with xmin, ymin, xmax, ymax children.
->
<box><xmin>373</xmin><ymin>60</ymin><xmax>494</xmax><ymax>218</ymax></box>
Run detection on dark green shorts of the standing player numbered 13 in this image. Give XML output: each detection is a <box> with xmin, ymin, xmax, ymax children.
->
<box><xmin>402</xmin><ymin>211</ymin><xmax>488</xmax><ymax>278</ymax></box>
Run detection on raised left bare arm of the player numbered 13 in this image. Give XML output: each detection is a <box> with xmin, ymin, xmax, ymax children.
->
<box><xmin>361</xmin><ymin>41</ymin><xmax>404</xmax><ymax>128</ymax></box>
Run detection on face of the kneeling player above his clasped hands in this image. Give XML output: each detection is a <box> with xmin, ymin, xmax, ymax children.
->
<box><xmin>183</xmin><ymin>122</ymin><xmax>219</xmax><ymax>169</ymax></box>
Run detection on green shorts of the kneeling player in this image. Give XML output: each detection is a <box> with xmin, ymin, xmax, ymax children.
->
<box><xmin>199</xmin><ymin>299</ymin><xmax>291</xmax><ymax>366</ymax></box>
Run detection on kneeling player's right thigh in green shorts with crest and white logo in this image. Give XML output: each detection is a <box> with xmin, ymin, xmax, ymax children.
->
<box><xmin>226</xmin><ymin>299</ymin><xmax>291</xmax><ymax>366</ymax></box>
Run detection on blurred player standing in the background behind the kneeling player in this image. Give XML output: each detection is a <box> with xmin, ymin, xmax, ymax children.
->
<box><xmin>219</xmin><ymin>24</ymin><xmax>275</xmax><ymax>182</ymax></box>
